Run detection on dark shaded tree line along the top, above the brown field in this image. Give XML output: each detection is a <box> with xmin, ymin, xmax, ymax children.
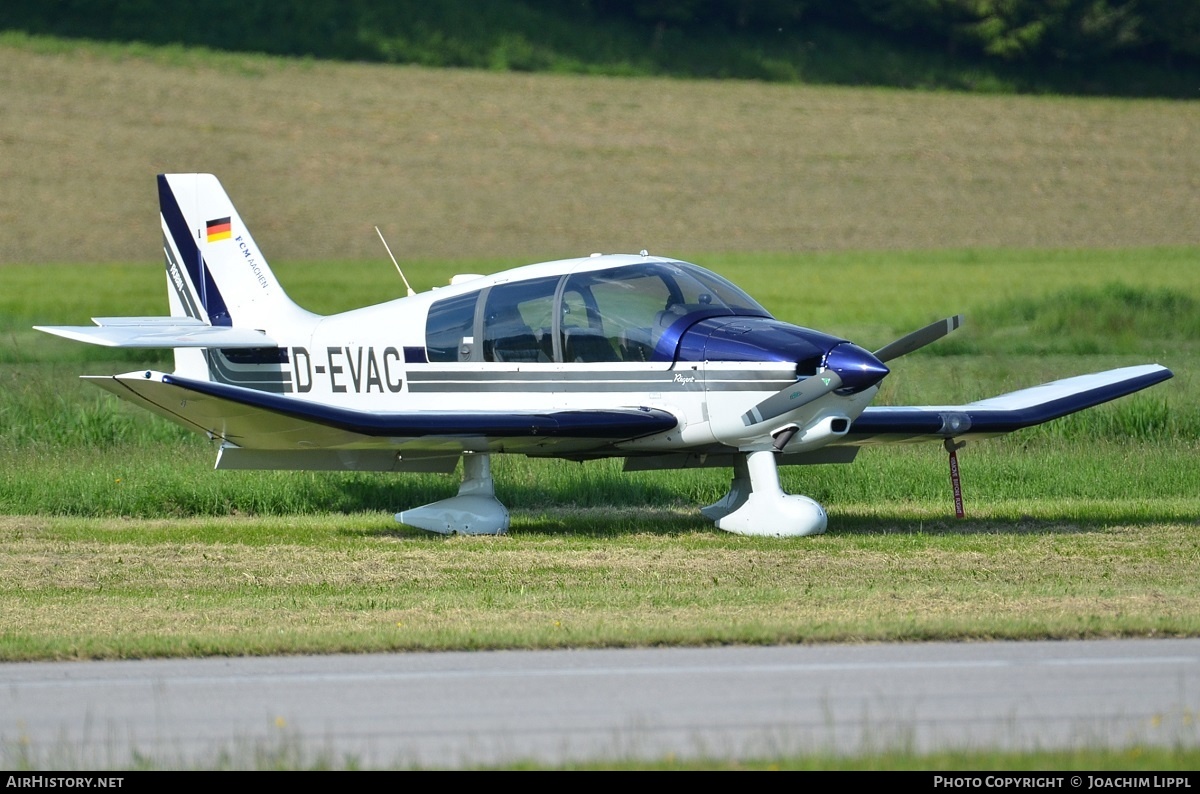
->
<box><xmin>0</xmin><ymin>0</ymin><xmax>1200</xmax><ymax>75</ymax></box>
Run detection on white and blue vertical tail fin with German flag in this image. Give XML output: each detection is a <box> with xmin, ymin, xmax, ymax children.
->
<box><xmin>158</xmin><ymin>174</ymin><xmax>312</xmax><ymax>329</ymax></box>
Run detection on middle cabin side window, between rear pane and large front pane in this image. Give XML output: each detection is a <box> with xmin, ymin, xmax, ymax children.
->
<box><xmin>484</xmin><ymin>276</ymin><xmax>559</xmax><ymax>362</ymax></box>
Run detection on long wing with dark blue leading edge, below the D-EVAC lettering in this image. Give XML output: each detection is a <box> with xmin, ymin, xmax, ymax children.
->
<box><xmin>85</xmin><ymin>371</ymin><xmax>678</xmax><ymax>470</ymax></box>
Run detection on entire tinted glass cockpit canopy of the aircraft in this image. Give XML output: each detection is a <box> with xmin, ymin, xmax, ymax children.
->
<box><xmin>425</xmin><ymin>261</ymin><xmax>770</xmax><ymax>362</ymax></box>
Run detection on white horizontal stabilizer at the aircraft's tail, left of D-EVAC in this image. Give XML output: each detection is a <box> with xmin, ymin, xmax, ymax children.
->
<box><xmin>34</xmin><ymin>317</ymin><xmax>278</xmax><ymax>348</ymax></box>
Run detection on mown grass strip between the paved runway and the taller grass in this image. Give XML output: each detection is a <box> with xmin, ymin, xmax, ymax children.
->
<box><xmin>0</xmin><ymin>498</ymin><xmax>1200</xmax><ymax>660</ymax></box>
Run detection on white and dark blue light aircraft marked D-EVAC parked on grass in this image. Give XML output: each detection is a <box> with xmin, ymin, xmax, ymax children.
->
<box><xmin>36</xmin><ymin>174</ymin><xmax>1172</xmax><ymax>536</ymax></box>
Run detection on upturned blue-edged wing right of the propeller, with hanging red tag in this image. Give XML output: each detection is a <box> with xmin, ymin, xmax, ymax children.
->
<box><xmin>839</xmin><ymin>365</ymin><xmax>1172</xmax><ymax>445</ymax></box>
